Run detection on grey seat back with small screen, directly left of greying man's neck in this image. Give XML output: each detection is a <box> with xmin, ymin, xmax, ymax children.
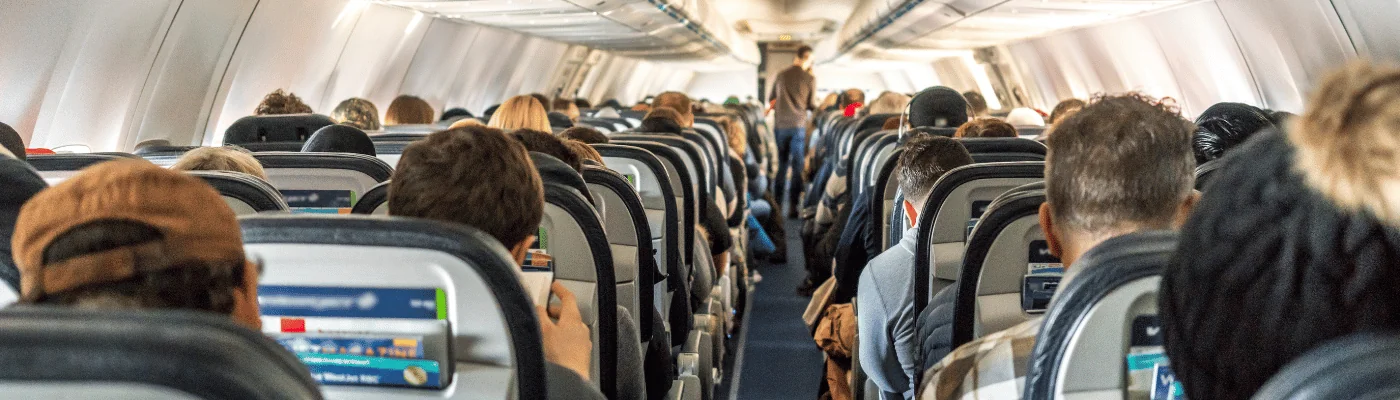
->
<box><xmin>952</xmin><ymin>182</ymin><xmax>1064</xmax><ymax>348</ymax></box>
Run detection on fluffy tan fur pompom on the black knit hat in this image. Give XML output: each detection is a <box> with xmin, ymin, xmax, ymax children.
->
<box><xmin>1288</xmin><ymin>62</ymin><xmax>1400</xmax><ymax>225</ymax></box>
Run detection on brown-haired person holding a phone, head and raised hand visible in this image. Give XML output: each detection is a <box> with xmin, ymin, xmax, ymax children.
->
<box><xmin>389</xmin><ymin>125</ymin><xmax>602</xmax><ymax>399</ymax></box>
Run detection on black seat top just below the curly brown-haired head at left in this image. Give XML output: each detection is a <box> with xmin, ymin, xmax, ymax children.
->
<box><xmin>224</xmin><ymin>113</ymin><xmax>336</xmax><ymax>152</ymax></box>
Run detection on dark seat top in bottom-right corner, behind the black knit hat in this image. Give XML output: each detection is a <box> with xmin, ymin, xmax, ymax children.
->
<box><xmin>1252</xmin><ymin>333</ymin><xmax>1400</xmax><ymax>400</ymax></box>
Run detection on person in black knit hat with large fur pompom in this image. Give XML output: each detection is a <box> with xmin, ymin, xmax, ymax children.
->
<box><xmin>1159</xmin><ymin>63</ymin><xmax>1400</xmax><ymax>400</ymax></box>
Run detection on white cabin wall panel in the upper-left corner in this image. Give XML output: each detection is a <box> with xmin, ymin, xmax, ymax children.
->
<box><xmin>0</xmin><ymin>0</ymin><xmax>179</xmax><ymax>150</ymax></box>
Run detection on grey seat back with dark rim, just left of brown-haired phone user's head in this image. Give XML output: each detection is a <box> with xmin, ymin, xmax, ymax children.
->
<box><xmin>253</xmin><ymin>151</ymin><xmax>393</xmax><ymax>214</ymax></box>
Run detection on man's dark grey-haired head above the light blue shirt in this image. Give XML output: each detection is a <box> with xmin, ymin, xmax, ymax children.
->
<box><xmin>899</xmin><ymin>136</ymin><xmax>973</xmax><ymax>221</ymax></box>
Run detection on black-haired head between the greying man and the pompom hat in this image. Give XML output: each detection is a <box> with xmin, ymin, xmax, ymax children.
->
<box><xmin>1191</xmin><ymin>102</ymin><xmax>1274</xmax><ymax>164</ymax></box>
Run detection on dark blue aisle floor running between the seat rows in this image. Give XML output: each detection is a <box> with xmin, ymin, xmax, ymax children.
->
<box><xmin>715</xmin><ymin>221</ymin><xmax>822</xmax><ymax>400</ymax></box>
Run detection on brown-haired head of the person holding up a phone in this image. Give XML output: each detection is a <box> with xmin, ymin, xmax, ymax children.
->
<box><xmin>389</xmin><ymin>126</ymin><xmax>545</xmax><ymax>262</ymax></box>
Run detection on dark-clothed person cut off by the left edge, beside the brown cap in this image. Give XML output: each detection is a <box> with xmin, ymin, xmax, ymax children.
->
<box><xmin>0</xmin><ymin>153</ymin><xmax>49</xmax><ymax>293</ymax></box>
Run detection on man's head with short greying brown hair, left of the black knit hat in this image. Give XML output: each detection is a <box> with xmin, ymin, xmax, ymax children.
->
<box><xmin>1040</xmin><ymin>94</ymin><xmax>1196</xmax><ymax>264</ymax></box>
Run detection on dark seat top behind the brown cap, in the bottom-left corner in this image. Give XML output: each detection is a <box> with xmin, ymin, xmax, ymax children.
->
<box><xmin>0</xmin><ymin>306</ymin><xmax>322</xmax><ymax>400</ymax></box>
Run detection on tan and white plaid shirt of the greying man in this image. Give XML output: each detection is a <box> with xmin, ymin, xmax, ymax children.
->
<box><xmin>918</xmin><ymin>317</ymin><xmax>1042</xmax><ymax>400</ymax></box>
